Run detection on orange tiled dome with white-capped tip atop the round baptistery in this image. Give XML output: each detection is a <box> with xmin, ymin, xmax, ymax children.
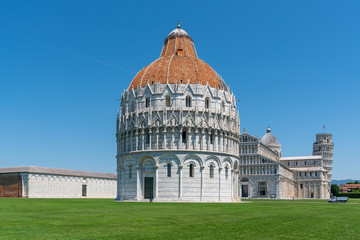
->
<box><xmin>129</xmin><ymin>23</ymin><xmax>228</xmax><ymax>90</ymax></box>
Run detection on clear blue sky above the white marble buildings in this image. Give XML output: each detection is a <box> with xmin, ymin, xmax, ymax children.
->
<box><xmin>0</xmin><ymin>0</ymin><xmax>360</xmax><ymax>179</ymax></box>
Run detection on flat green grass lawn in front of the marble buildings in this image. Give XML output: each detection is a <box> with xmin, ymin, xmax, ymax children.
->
<box><xmin>0</xmin><ymin>199</ymin><xmax>360</xmax><ymax>240</ymax></box>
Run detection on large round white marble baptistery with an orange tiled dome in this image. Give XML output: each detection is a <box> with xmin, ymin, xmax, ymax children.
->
<box><xmin>116</xmin><ymin>23</ymin><xmax>240</xmax><ymax>202</ymax></box>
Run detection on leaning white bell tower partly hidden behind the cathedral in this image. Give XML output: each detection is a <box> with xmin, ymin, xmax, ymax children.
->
<box><xmin>313</xmin><ymin>133</ymin><xmax>334</xmax><ymax>193</ymax></box>
